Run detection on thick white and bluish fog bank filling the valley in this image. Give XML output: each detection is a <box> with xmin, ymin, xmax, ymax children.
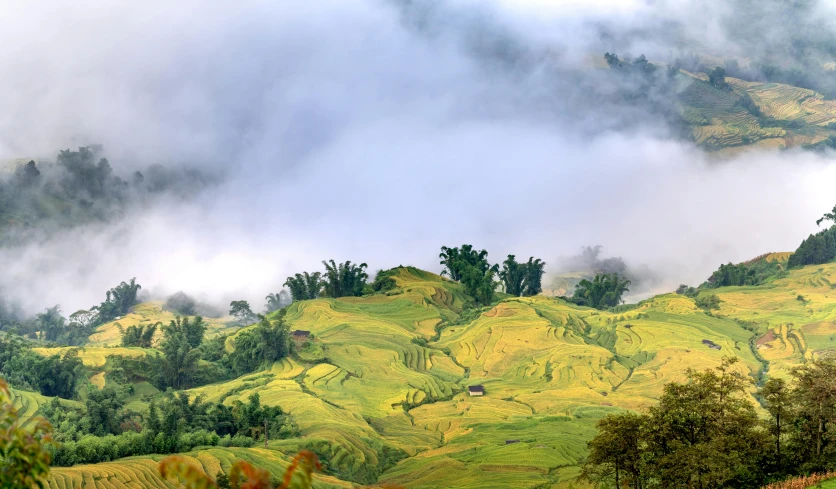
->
<box><xmin>0</xmin><ymin>0</ymin><xmax>836</xmax><ymax>312</ymax></box>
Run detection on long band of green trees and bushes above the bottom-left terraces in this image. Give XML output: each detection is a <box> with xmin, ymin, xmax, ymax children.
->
<box><xmin>44</xmin><ymin>388</ymin><xmax>297</xmax><ymax>466</ymax></box>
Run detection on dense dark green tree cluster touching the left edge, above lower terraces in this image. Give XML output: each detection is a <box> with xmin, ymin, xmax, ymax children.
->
<box><xmin>0</xmin><ymin>335</ymin><xmax>85</xmax><ymax>399</ymax></box>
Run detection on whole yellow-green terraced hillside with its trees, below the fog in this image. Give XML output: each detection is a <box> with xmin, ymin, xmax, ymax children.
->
<box><xmin>11</xmin><ymin>231</ymin><xmax>836</xmax><ymax>489</ymax></box>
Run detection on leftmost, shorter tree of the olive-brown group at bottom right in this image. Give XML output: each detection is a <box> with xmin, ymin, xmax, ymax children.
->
<box><xmin>581</xmin><ymin>413</ymin><xmax>647</xmax><ymax>489</ymax></box>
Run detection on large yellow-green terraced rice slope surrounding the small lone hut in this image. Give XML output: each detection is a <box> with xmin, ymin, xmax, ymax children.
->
<box><xmin>42</xmin><ymin>264</ymin><xmax>836</xmax><ymax>488</ymax></box>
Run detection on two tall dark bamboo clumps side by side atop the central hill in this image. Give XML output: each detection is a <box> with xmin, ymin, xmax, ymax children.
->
<box><xmin>438</xmin><ymin>244</ymin><xmax>546</xmax><ymax>305</ymax></box>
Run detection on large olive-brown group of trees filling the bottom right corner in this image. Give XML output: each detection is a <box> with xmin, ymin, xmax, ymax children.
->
<box><xmin>583</xmin><ymin>358</ymin><xmax>836</xmax><ymax>489</ymax></box>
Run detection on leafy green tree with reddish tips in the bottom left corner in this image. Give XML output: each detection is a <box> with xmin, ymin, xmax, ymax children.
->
<box><xmin>0</xmin><ymin>379</ymin><xmax>54</xmax><ymax>488</ymax></box>
